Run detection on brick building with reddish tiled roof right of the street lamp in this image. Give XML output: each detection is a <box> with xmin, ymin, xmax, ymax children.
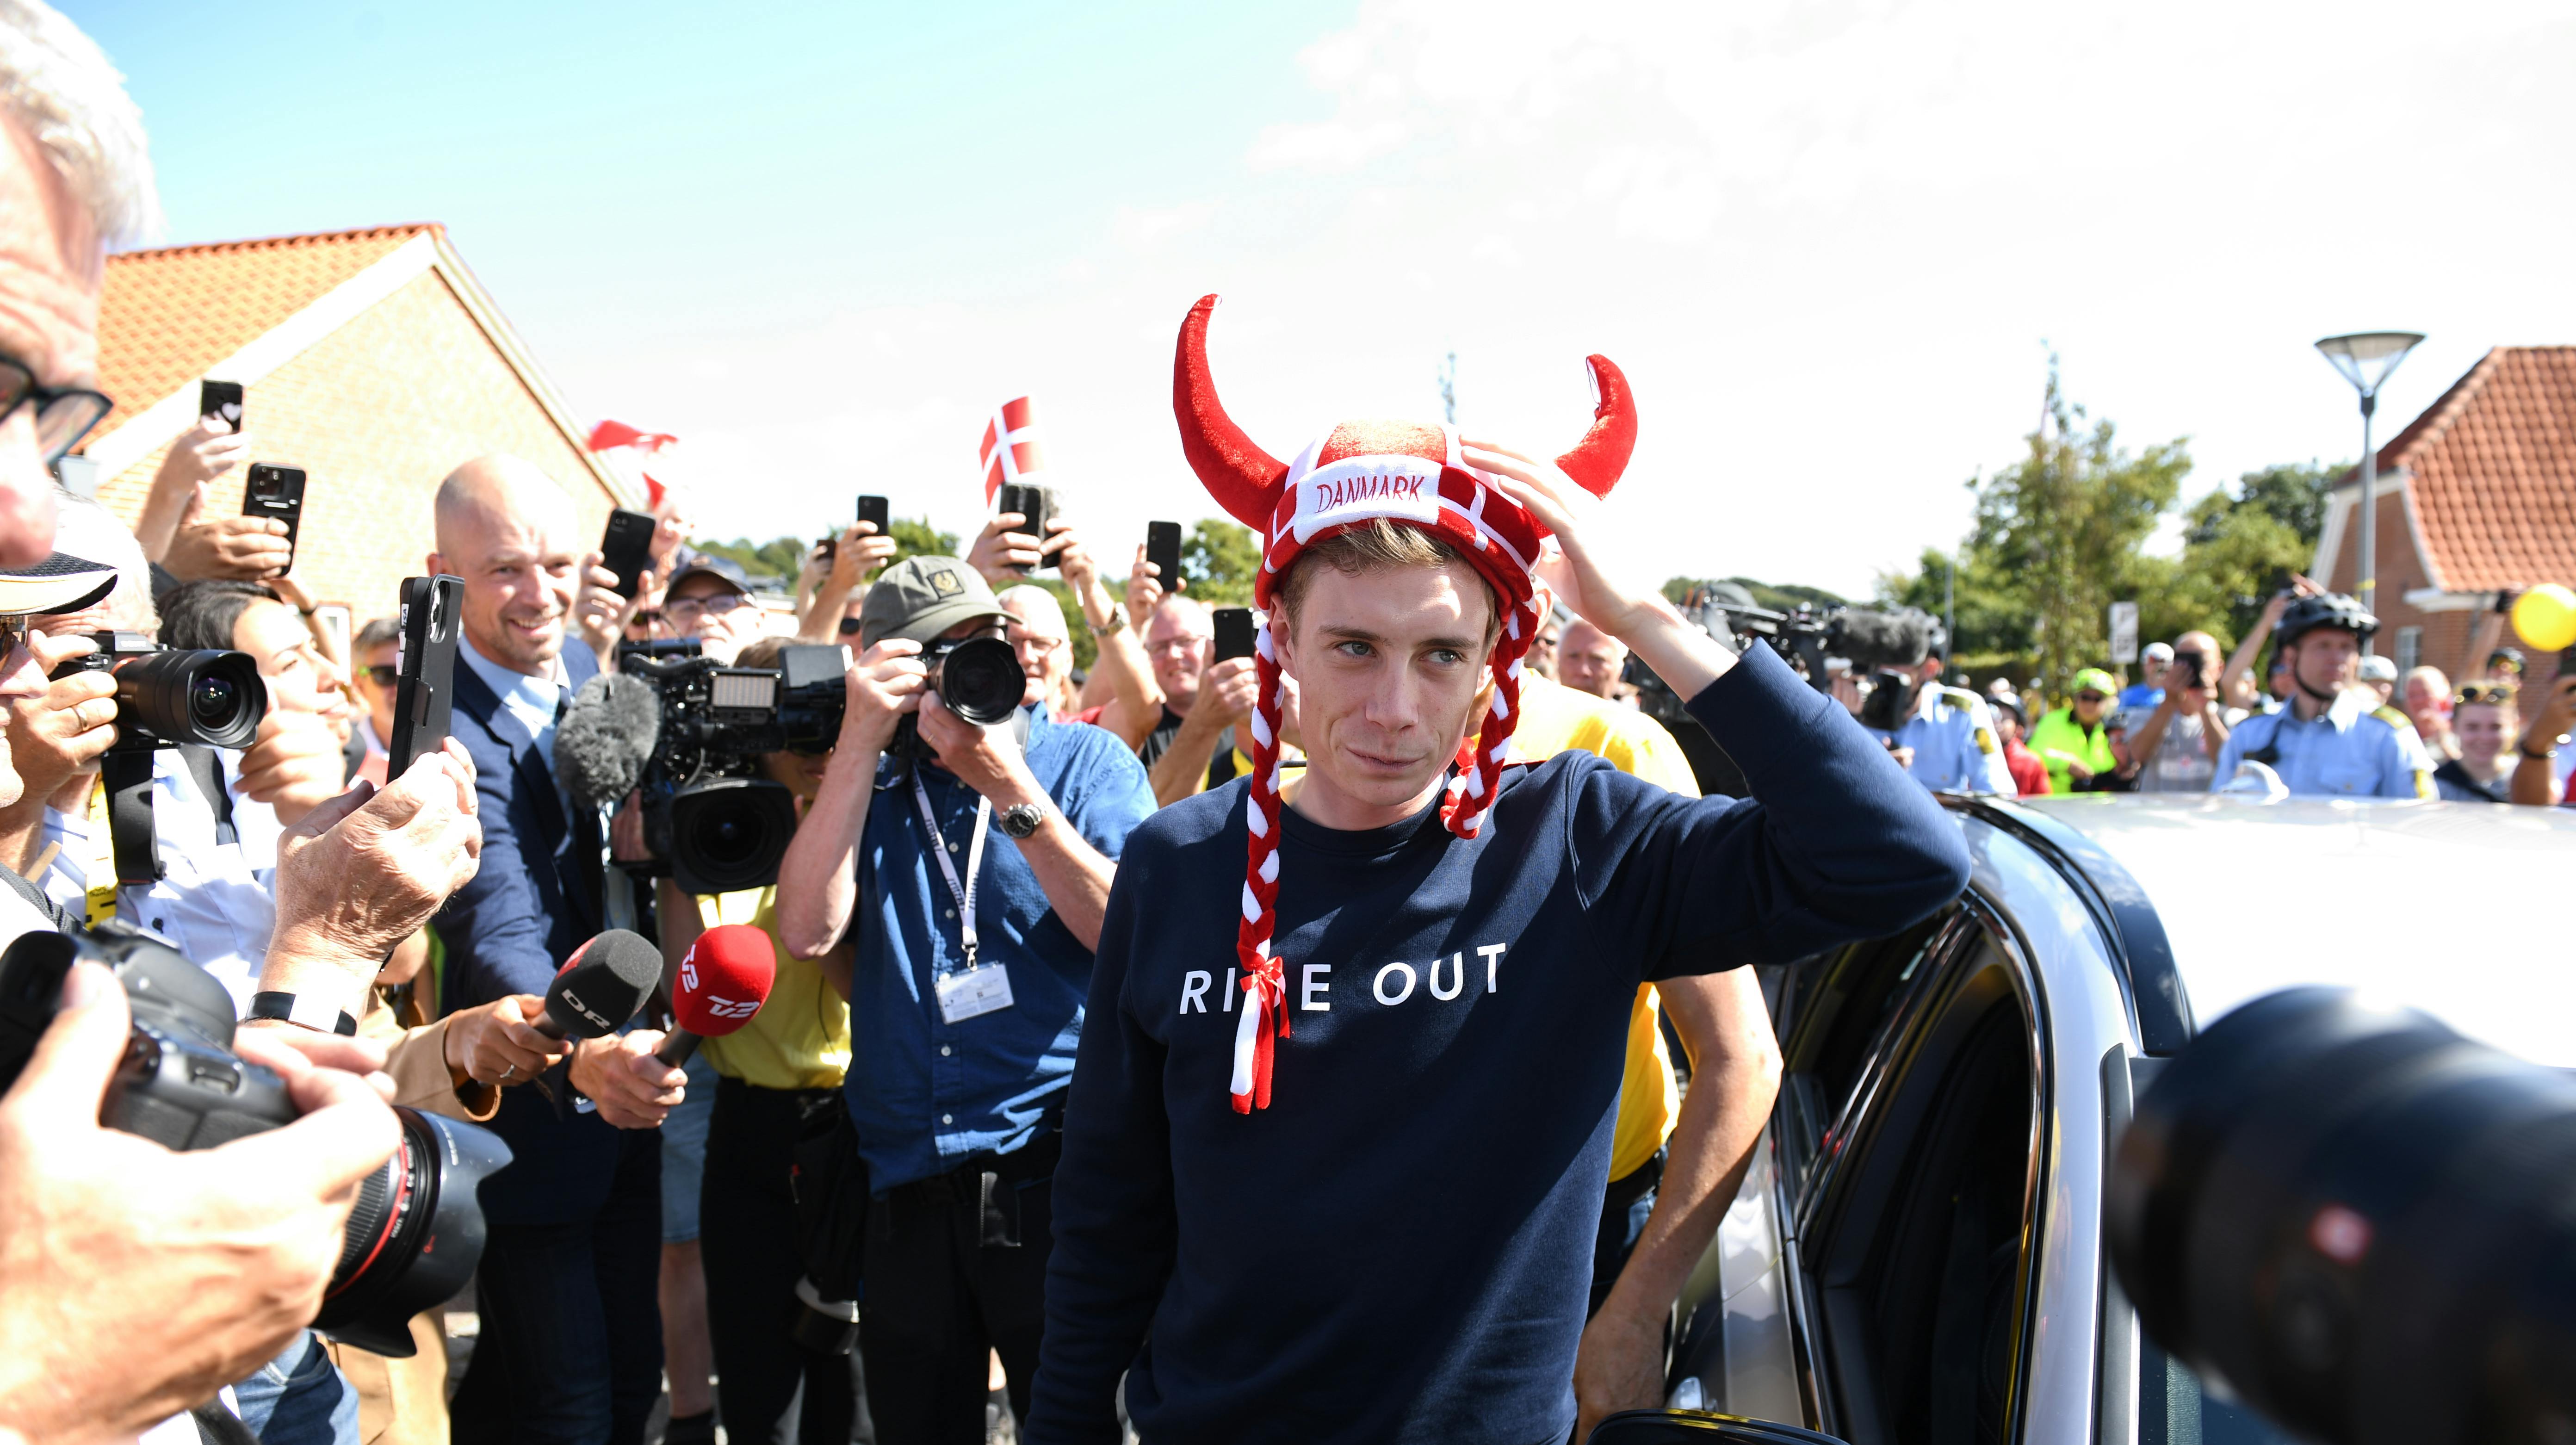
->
<box><xmin>2310</xmin><ymin>345</ymin><xmax>2576</xmax><ymax>685</ymax></box>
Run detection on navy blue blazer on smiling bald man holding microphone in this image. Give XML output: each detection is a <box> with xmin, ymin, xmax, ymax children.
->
<box><xmin>438</xmin><ymin>639</ymin><xmax>633</xmax><ymax>1226</ymax></box>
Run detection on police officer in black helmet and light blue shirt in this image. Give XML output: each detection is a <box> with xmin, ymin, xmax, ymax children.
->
<box><xmin>2213</xmin><ymin>592</ymin><xmax>2434</xmax><ymax>799</ymax></box>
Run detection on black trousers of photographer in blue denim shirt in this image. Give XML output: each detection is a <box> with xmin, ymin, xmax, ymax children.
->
<box><xmin>858</xmin><ymin>1133</ymin><xmax>1061</xmax><ymax>1445</ymax></box>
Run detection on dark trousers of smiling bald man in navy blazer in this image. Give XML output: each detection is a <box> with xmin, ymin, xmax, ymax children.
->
<box><xmin>448</xmin><ymin>1128</ymin><xmax>662</xmax><ymax>1445</ymax></box>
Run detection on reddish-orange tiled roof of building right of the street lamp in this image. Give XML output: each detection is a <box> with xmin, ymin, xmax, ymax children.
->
<box><xmin>2380</xmin><ymin>345</ymin><xmax>2576</xmax><ymax>592</ymax></box>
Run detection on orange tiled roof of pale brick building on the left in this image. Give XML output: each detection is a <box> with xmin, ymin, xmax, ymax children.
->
<box><xmin>90</xmin><ymin>224</ymin><xmax>438</xmax><ymax>435</ymax></box>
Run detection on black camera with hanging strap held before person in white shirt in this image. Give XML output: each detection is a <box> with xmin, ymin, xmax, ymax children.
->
<box><xmin>54</xmin><ymin>631</ymin><xmax>268</xmax><ymax>886</ymax></box>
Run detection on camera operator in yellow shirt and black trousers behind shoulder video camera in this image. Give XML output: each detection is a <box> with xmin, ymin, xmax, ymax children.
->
<box><xmin>657</xmin><ymin>639</ymin><xmax>870</xmax><ymax>1445</ymax></box>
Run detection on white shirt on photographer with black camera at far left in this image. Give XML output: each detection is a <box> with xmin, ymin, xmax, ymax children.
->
<box><xmin>33</xmin><ymin>747</ymin><xmax>283</xmax><ymax>1012</ymax></box>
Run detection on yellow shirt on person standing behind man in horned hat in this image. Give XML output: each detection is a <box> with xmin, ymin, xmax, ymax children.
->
<box><xmin>1512</xmin><ymin>672</ymin><xmax>1700</xmax><ymax>1180</ymax></box>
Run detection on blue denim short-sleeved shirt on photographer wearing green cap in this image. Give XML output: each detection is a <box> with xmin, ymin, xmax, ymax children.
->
<box><xmin>842</xmin><ymin>708</ymin><xmax>1154</xmax><ymax>1192</ymax></box>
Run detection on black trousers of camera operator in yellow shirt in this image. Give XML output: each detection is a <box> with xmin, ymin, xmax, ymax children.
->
<box><xmin>698</xmin><ymin>1079</ymin><xmax>876</xmax><ymax>1445</ymax></box>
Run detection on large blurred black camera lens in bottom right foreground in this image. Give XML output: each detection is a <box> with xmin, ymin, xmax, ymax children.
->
<box><xmin>2102</xmin><ymin>986</ymin><xmax>2576</xmax><ymax>1445</ymax></box>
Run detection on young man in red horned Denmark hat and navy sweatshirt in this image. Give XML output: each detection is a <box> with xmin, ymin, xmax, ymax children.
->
<box><xmin>1015</xmin><ymin>296</ymin><xmax>1968</xmax><ymax>1445</ymax></box>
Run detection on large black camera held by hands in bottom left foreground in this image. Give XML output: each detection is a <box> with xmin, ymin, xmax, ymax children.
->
<box><xmin>0</xmin><ymin>919</ymin><xmax>510</xmax><ymax>1358</ymax></box>
